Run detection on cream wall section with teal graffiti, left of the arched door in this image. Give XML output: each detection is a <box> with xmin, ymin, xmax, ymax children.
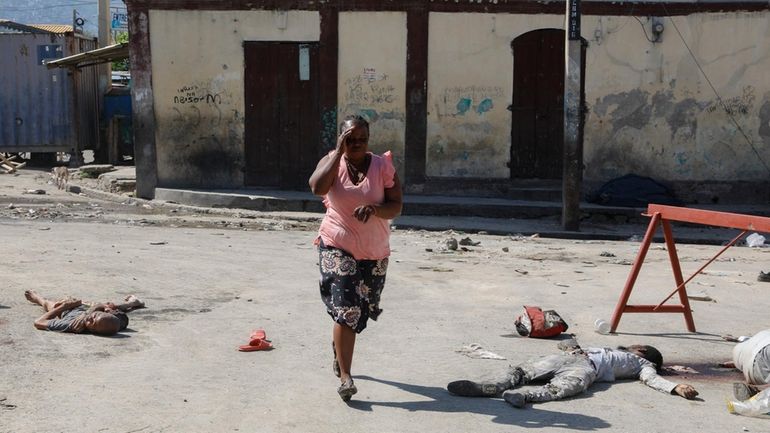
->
<box><xmin>426</xmin><ymin>13</ymin><xmax>564</xmax><ymax>178</ymax></box>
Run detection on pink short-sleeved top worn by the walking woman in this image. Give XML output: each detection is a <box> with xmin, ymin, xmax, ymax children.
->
<box><xmin>318</xmin><ymin>151</ymin><xmax>396</xmax><ymax>260</ymax></box>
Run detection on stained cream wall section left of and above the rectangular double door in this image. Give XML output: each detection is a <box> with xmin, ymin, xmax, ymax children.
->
<box><xmin>150</xmin><ymin>10</ymin><xmax>320</xmax><ymax>187</ymax></box>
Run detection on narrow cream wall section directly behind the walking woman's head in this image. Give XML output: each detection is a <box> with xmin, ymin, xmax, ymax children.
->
<box><xmin>337</xmin><ymin>12</ymin><xmax>406</xmax><ymax>177</ymax></box>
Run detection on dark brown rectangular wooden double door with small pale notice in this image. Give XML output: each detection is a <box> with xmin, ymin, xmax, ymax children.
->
<box><xmin>243</xmin><ymin>42</ymin><xmax>321</xmax><ymax>189</ymax></box>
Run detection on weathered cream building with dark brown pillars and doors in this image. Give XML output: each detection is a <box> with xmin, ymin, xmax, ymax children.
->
<box><xmin>126</xmin><ymin>0</ymin><xmax>770</xmax><ymax>202</ymax></box>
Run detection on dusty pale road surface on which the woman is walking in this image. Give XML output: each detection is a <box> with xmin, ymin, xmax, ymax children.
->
<box><xmin>0</xmin><ymin>168</ymin><xmax>770</xmax><ymax>433</ymax></box>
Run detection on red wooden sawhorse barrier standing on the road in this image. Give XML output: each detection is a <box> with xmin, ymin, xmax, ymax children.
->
<box><xmin>610</xmin><ymin>204</ymin><xmax>770</xmax><ymax>332</ymax></box>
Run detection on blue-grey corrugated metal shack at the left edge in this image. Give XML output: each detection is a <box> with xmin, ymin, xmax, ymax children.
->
<box><xmin>0</xmin><ymin>20</ymin><xmax>99</xmax><ymax>162</ymax></box>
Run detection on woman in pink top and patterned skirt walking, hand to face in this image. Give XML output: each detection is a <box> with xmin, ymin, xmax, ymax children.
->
<box><xmin>308</xmin><ymin>116</ymin><xmax>402</xmax><ymax>401</ymax></box>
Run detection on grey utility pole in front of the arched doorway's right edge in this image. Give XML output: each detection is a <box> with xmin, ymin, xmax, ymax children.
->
<box><xmin>561</xmin><ymin>0</ymin><xmax>583</xmax><ymax>231</ymax></box>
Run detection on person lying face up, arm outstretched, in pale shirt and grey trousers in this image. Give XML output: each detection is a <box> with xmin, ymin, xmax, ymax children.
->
<box><xmin>447</xmin><ymin>340</ymin><xmax>698</xmax><ymax>408</ymax></box>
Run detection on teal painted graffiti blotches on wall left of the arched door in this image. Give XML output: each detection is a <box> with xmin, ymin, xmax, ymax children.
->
<box><xmin>438</xmin><ymin>86</ymin><xmax>504</xmax><ymax>117</ymax></box>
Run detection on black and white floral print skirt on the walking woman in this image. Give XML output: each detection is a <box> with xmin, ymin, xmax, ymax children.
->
<box><xmin>318</xmin><ymin>242</ymin><xmax>388</xmax><ymax>333</ymax></box>
